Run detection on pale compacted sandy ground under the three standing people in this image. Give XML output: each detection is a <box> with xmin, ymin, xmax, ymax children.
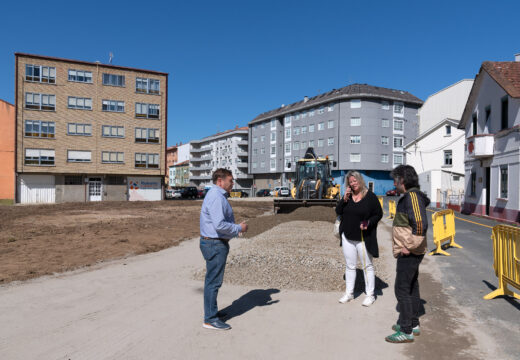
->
<box><xmin>0</xmin><ymin>220</ymin><xmax>502</xmax><ymax>360</ymax></box>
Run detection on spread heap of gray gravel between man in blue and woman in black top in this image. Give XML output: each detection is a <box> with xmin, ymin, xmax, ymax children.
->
<box><xmin>195</xmin><ymin>219</ymin><xmax>387</xmax><ymax>291</ymax></box>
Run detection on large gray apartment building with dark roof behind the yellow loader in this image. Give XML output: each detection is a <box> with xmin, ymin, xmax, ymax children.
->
<box><xmin>248</xmin><ymin>84</ymin><xmax>423</xmax><ymax>195</ymax></box>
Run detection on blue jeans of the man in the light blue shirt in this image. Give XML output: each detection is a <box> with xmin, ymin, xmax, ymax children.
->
<box><xmin>200</xmin><ymin>238</ymin><xmax>229</xmax><ymax>323</ymax></box>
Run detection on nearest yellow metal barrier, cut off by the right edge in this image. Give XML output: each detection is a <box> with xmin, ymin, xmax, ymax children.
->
<box><xmin>484</xmin><ymin>225</ymin><xmax>520</xmax><ymax>300</ymax></box>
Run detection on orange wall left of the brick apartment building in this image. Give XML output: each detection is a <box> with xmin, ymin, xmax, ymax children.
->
<box><xmin>0</xmin><ymin>100</ymin><xmax>16</xmax><ymax>201</ymax></box>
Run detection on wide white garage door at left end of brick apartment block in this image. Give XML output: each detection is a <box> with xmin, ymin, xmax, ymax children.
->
<box><xmin>18</xmin><ymin>174</ymin><xmax>56</xmax><ymax>204</ymax></box>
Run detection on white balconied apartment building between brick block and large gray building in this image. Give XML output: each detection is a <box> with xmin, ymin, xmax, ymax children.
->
<box><xmin>190</xmin><ymin>126</ymin><xmax>253</xmax><ymax>190</ymax></box>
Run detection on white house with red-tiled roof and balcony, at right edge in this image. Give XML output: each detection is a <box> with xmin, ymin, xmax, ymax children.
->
<box><xmin>459</xmin><ymin>55</ymin><xmax>520</xmax><ymax>222</ymax></box>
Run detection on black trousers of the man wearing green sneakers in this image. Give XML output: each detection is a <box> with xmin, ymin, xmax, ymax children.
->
<box><xmin>395</xmin><ymin>254</ymin><xmax>424</xmax><ymax>334</ymax></box>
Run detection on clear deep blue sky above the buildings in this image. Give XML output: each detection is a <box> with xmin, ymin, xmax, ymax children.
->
<box><xmin>0</xmin><ymin>0</ymin><xmax>520</xmax><ymax>145</ymax></box>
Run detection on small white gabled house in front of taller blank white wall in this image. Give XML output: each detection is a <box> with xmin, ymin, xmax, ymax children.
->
<box><xmin>405</xmin><ymin>119</ymin><xmax>465</xmax><ymax>210</ymax></box>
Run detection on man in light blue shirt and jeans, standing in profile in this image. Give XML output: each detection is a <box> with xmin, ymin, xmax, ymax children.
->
<box><xmin>200</xmin><ymin>168</ymin><xmax>247</xmax><ymax>330</ymax></box>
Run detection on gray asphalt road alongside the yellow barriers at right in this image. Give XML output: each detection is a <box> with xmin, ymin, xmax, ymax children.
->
<box><xmin>385</xmin><ymin>198</ymin><xmax>520</xmax><ymax>359</ymax></box>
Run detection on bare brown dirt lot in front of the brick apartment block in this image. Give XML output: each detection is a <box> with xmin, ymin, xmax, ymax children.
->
<box><xmin>0</xmin><ymin>201</ymin><xmax>272</xmax><ymax>284</ymax></box>
